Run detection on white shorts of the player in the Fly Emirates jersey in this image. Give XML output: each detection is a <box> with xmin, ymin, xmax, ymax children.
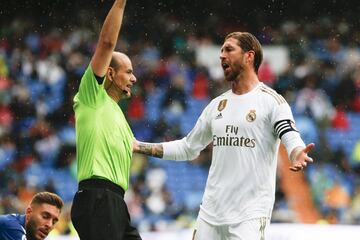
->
<box><xmin>193</xmin><ymin>217</ymin><xmax>270</xmax><ymax>240</ymax></box>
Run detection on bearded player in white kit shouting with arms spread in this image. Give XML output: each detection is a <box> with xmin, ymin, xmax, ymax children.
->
<box><xmin>134</xmin><ymin>32</ymin><xmax>314</xmax><ymax>240</ymax></box>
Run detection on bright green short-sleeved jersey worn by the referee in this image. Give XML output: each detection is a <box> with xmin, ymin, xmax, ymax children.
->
<box><xmin>74</xmin><ymin>65</ymin><xmax>134</xmax><ymax>190</ymax></box>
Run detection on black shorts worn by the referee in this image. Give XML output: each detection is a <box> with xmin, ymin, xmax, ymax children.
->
<box><xmin>71</xmin><ymin>179</ymin><xmax>141</xmax><ymax>240</ymax></box>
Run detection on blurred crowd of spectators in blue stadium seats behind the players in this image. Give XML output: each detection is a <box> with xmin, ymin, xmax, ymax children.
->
<box><xmin>0</xmin><ymin>0</ymin><xmax>360</xmax><ymax>234</ymax></box>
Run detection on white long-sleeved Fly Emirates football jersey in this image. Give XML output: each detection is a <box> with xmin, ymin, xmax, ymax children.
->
<box><xmin>163</xmin><ymin>83</ymin><xmax>304</xmax><ymax>225</ymax></box>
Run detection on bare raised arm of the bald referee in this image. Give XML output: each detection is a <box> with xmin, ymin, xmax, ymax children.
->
<box><xmin>91</xmin><ymin>0</ymin><xmax>126</xmax><ymax>77</ymax></box>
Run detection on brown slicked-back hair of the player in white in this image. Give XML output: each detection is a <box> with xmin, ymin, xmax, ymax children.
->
<box><xmin>225</xmin><ymin>32</ymin><xmax>263</xmax><ymax>73</ymax></box>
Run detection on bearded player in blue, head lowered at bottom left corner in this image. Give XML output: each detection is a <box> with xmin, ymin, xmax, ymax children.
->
<box><xmin>0</xmin><ymin>192</ymin><xmax>64</xmax><ymax>240</ymax></box>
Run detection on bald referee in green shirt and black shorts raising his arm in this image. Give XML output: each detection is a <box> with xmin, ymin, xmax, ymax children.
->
<box><xmin>71</xmin><ymin>0</ymin><xmax>141</xmax><ymax>240</ymax></box>
